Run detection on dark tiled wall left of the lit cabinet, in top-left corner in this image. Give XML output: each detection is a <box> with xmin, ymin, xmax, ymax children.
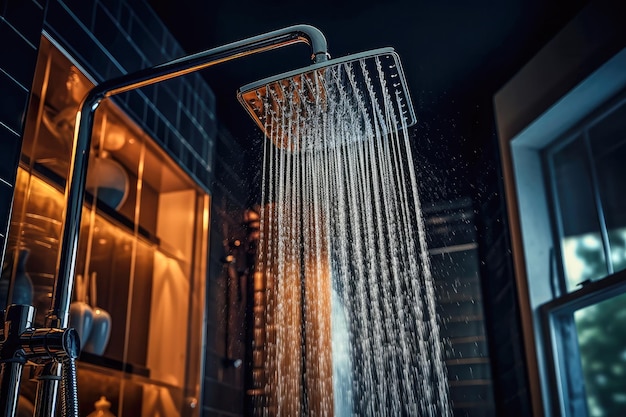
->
<box><xmin>0</xmin><ymin>0</ymin><xmax>45</xmax><ymax>259</ymax></box>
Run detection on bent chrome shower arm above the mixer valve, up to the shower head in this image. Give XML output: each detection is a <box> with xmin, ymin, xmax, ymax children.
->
<box><xmin>47</xmin><ymin>25</ymin><xmax>328</xmax><ymax>328</ymax></box>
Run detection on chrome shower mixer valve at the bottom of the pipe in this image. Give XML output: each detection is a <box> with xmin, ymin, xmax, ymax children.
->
<box><xmin>0</xmin><ymin>304</ymin><xmax>80</xmax><ymax>417</ymax></box>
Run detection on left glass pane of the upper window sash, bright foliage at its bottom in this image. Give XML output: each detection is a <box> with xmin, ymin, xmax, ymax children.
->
<box><xmin>552</xmin><ymin>136</ymin><xmax>608</xmax><ymax>291</ymax></box>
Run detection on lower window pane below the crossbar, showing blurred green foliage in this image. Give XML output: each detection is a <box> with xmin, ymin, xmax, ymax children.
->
<box><xmin>574</xmin><ymin>294</ymin><xmax>626</xmax><ymax>417</ymax></box>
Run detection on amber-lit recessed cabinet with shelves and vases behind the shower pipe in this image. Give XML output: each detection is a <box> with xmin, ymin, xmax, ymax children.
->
<box><xmin>2</xmin><ymin>38</ymin><xmax>210</xmax><ymax>417</ymax></box>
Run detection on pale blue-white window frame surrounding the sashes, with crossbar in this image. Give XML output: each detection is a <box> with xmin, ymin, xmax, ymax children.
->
<box><xmin>503</xmin><ymin>49</ymin><xmax>626</xmax><ymax>417</ymax></box>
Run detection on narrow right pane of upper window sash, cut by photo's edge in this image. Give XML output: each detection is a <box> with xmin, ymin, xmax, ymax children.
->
<box><xmin>589</xmin><ymin>104</ymin><xmax>626</xmax><ymax>271</ymax></box>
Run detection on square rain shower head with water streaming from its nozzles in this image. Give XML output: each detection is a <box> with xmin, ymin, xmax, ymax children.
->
<box><xmin>237</xmin><ymin>48</ymin><xmax>416</xmax><ymax>150</ymax></box>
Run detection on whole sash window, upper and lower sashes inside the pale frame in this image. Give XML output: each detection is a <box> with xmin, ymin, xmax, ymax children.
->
<box><xmin>541</xmin><ymin>94</ymin><xmax>626</xmax><ymax>417</ymax></box>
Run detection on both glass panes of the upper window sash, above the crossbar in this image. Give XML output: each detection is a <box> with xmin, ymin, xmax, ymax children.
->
<box><xmin>546</xmin><ymin>101</ymin><xmax>626</xmax><ymax>291</ymax></box>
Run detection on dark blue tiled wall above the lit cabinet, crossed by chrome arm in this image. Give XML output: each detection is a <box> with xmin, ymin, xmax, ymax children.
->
<box><xmin>44</xmin><ymin>0</ymin><xmax>217</xmax><ymax>191</ymax></box>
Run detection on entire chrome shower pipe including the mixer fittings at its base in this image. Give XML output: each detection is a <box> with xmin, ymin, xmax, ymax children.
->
<box><xmin>0</xmin><ymin>25</ymin><xmax>328</xmax><ymax>417</ymax></box>
